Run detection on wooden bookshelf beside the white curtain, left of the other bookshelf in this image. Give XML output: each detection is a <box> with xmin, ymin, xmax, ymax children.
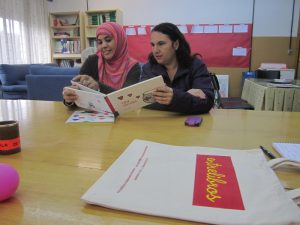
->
<box><xmin>49</xmin><ymin>12</ymin><xmax>84</xmax><ymax>66</ymax></box>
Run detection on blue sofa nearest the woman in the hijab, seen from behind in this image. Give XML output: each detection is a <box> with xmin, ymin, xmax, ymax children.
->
<box><xmin>26</xmin><ymin>65</ymin><xmax>80</xmax><ymax>101</ymax></box>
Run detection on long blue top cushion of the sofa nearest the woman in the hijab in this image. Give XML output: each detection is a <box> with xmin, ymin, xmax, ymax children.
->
<box><xmin>29</xmin><ymin>65</ymin><xmax>80</xmax><ymax>75</ymax></box>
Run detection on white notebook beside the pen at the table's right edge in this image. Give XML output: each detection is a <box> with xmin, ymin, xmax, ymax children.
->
<box><xmin>272</xmin><ymin>142</ymin><xmax>300</xmax><ymax>163</ymax></box>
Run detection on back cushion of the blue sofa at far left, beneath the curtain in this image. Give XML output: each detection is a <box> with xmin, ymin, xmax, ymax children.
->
<box><xmin>0</xmin><ymin>64</ymin><xmax>29</xmax><ymax>85</ymax></box>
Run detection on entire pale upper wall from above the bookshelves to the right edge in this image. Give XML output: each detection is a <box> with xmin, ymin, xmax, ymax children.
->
<box><xmin>49</xmin><ymin>0</ymin><xmax>300</xmax><ymax>37</ymax></box>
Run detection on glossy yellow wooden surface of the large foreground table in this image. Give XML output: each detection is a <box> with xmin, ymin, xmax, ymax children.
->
<box><xmin>0</xmin><ymin>100</ymin><xmax>300</xmax><ymax>225</ymax></box>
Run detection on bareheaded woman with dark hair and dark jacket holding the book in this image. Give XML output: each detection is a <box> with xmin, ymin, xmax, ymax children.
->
<box><xmin>141</xmin><ymin>23</ymin><xmax>214</xmax><ymax>114</ymax></box>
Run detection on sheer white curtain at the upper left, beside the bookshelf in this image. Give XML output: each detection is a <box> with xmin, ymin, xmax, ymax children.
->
<box><xmin>0</xmin><ymin>0</ymin><xmax>51</xmax><ymax>64</ymax></box>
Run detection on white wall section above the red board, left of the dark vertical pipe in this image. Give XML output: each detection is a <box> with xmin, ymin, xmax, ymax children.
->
<box><xmin>89</xmin><ymin>0</ymin><xmax>252</xmax><ymax>25</ymax></box>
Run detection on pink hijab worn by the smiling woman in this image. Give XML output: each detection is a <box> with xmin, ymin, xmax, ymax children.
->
<box><xmin>96</xmin><ymin>22</ymin><xmax>138</xmax><ymax>89</ymax></box>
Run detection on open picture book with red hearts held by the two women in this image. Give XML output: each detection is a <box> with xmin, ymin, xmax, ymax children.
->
<box><xmin>67</xmin><ymin>76</ymin><xmax>164</xmax><ymax>116</ymax></box>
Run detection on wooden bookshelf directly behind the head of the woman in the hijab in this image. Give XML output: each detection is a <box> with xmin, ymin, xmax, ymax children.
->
<box><xmin>84</xmin><ymin>9</ymin><xmax>123</xmax><ymax>47</ymax></box>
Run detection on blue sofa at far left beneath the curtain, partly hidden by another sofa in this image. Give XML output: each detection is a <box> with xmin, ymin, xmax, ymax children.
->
<box><xmin>0</xmin><ymin>63</ymin><xmax>57</xmax><ymax>99</ymax></box>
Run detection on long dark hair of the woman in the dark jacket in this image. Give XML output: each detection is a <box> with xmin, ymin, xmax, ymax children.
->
<box><xmin>148</xmin><ymin>23</ymin><xmax>198</xmax><ymax>68</ymax></box>
